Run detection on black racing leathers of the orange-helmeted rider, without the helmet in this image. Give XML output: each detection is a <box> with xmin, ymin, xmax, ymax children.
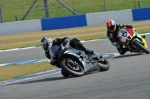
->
<box><xmin>107</xmin><ymin>24</ymin><xmax>133</xmax><ymax>55</ymax></box>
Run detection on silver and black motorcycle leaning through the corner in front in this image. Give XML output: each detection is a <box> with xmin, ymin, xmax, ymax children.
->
<box><xmin>49</xmin><ymin>40</ymin><xmax>110</xmax><ymax>77</ymax></box>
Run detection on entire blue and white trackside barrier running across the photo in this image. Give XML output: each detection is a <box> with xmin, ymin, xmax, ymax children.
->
<box><xmin>0</xmin><ymin>8</ymin><xmax>150</xmax><ymax>34</ymax></box>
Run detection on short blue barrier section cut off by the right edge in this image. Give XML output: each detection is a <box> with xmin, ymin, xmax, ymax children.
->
<box><xmin>132</xmin><ymin>8</ymin><xmax>150</xmax><ymax>21</ymax></box>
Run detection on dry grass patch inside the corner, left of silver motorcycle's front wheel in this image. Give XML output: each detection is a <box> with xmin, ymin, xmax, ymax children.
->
<box><xmin>0</xmin><ymin>62</ymin><xmax>56</xmax><ymax>81</ymax></box>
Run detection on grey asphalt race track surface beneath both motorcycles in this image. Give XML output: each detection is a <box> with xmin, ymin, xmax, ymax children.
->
<box><xmin>0</xmin><ymin>35</ymin><xmax>150</xmax><ymax>99</ymax></box>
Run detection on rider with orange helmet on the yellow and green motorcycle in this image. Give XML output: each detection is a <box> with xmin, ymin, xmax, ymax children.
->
<box><xmin>106</xmin><ymin>19</ymin><xmax>135</xmax><ymax>55</ymax></box>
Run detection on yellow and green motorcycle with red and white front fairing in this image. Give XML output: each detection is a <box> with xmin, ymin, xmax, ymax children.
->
<box><xmin>118</xmin><ymin>28</ymin><xmax>150</xmax><ymax>54</ymax></box>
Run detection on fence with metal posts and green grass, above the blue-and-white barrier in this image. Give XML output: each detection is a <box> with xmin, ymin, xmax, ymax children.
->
<box><xmin>0</xmin><ymin>0</ymin><xmax>150</xmax><ymax>22</ymax></box>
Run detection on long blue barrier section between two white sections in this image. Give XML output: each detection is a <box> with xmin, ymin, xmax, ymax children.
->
<box><xmin>41</xmin><ymin>15</ymin><xmax>87</xmax><ymax>31</ymax></box>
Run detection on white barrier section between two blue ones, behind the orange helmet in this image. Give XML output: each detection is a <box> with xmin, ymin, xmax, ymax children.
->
<box><xmin>86</xmin><ymin>9</ymin><xmax>133</xmax><ymax>26</ymax></box>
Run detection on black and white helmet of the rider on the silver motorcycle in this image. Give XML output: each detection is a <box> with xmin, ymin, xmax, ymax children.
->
<box><xmin>41</xmin><ymin>36</ymin><xmax>53</xmax><ymax>51</ymax></box>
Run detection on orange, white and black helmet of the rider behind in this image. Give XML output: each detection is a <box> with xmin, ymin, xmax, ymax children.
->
<box><xmin>106</xmin><ymin>19</ymin><xmax>116</xmax><ymax>32</ymax></box>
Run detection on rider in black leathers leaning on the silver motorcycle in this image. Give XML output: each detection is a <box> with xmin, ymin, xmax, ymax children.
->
<box><xmin>41</xmin><ymin>36</ymin><xmax>94</xmax><ymax>67</ymax></box>
